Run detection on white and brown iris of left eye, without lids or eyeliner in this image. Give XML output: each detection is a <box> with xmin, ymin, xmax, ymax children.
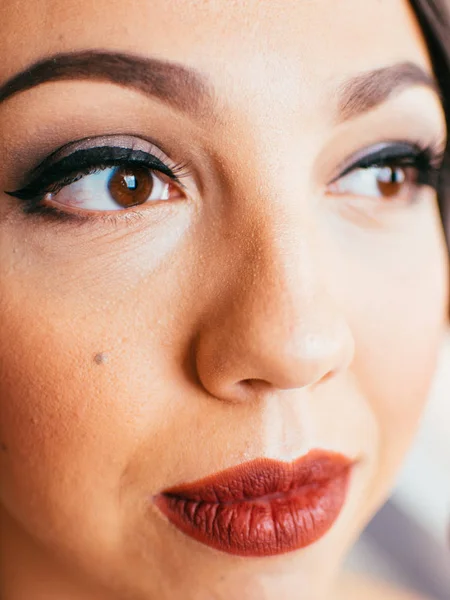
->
<box><xmin>42</xmin><ymin>165</ymin><xmax>182</xmax><ymax>211</ymax></box>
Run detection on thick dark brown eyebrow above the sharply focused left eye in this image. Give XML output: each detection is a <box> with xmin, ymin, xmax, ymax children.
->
<box><xmin>0</xmin><ymin>50</ymin><xmax>213</xmax><ymax>113</ymax></box>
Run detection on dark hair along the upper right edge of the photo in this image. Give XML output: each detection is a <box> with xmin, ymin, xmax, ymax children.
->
<box><xmin>410</xmin><ymin>0</ymin><xmax>450</xmax><ymax>254</ymax></box>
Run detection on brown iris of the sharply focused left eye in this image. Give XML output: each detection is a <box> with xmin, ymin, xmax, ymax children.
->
<box><xmin>108</xmin><ymin>167</ymin><xmax>153</xmax><ymax>208</ymax></box>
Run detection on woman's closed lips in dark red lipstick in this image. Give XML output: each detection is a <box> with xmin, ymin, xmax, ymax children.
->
<box><xmin>154</xmin><ymin>450</ymin><xmax>355</xmax><ymax>557</ymax></box>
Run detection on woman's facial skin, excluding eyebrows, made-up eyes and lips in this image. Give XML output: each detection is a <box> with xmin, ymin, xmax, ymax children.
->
<box><xmin>0</xmin><ymin>0</ymin><xmax>448</xmax><ymax>600</ymax></box>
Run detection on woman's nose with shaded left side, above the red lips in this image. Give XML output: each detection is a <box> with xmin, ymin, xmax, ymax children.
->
<box><xmin>195</xmin><ymin>214</ymin><xmax>354</xmax><ymax>402</ymax></box>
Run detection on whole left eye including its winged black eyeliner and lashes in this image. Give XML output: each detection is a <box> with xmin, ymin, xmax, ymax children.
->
<box><xmin>5</xmin><ymin>136</ymin><xmax>189</xmax><ymax>222</ymax></box>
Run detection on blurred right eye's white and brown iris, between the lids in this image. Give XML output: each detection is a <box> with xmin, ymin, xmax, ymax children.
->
<box><xmin>328</xmin><ymin>166</ymin><xmax>419</xmax><ymax>201</ymax></box>
